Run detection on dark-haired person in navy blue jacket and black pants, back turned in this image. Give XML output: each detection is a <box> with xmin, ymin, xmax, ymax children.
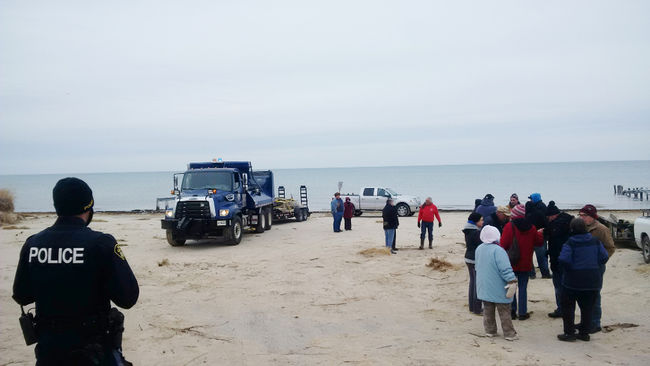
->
<box><xmin>557</xmin><ymin>218</ymin><xmax>609</xmax><ymax>342</ymax></box>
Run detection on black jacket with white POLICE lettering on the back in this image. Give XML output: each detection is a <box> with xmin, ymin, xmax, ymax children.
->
<box><xmin>13</xmin><ymin>217</ymin><xmax>140</xmax><ymax>324</ymax></box>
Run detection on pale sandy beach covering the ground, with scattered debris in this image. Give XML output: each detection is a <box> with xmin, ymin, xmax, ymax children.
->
<box><xmin>0</xmin><ymin>213</ymin><xmax>650</xmax><ymax>365</ymax></box>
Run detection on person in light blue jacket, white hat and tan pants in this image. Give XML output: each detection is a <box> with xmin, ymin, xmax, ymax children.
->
<box><xmin>475</xmin><ymin>225</ymin><xmax>517</xmax><ymax>341</ymax></box>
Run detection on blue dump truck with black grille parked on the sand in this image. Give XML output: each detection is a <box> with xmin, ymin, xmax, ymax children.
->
<box><xmin>161</xmin><ymin>161</ymin><xmax>274</xmax><ymax>246</ymax></box>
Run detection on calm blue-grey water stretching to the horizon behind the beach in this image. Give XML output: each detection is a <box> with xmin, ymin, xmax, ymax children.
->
<box><xmin>0</xmin><ymin>161</ymin><xmax>650</xmax><ymax>212</ymax></box>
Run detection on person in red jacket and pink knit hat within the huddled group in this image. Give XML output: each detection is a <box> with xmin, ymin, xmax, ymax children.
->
<box><xmin>500</xmin><ymin>204</ymin><xmax>544</xmax><ymax>320</ymax></box>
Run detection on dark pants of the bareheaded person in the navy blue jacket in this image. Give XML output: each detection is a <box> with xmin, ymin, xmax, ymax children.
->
<box><xmin>562</xmin><ymin>288</ymin><xmax>598</xmax><ymax>334</ymax></box>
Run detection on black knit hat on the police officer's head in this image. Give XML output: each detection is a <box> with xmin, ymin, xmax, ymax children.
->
<box><xmin>52</xmin><ymin>178</ymin><xmax>95</xmax><ymax>216</ymax></box>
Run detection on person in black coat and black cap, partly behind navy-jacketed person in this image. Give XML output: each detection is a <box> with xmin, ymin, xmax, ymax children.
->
<box><xmin>544</xmin><ymin>201</ymin><xmax>573</xmax><ymax>318</ymax></box>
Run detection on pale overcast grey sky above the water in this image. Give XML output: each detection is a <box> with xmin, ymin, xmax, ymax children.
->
<box><xmin>0</xmin><ymin>0</ymin><xmax>650</xmax><ymax>174</ymax></box>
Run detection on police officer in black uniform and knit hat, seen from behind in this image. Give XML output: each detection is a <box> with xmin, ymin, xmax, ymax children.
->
<box><xmin>13</xmin><ymin>178</ymin><xmax>139</xmax><ymax>366</ymax></box>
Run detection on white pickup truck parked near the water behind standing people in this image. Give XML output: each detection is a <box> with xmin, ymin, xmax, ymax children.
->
<box><xmin>341</xmin><ymin>186</ymin><xmax>421</xmax><ymax>216</ymax></box>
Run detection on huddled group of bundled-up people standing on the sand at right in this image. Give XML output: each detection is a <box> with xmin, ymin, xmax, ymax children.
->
<box><xmin>462</xmin><ymin>193</ymin><xmax>615</xmax><ymax>341</ymax></box>
